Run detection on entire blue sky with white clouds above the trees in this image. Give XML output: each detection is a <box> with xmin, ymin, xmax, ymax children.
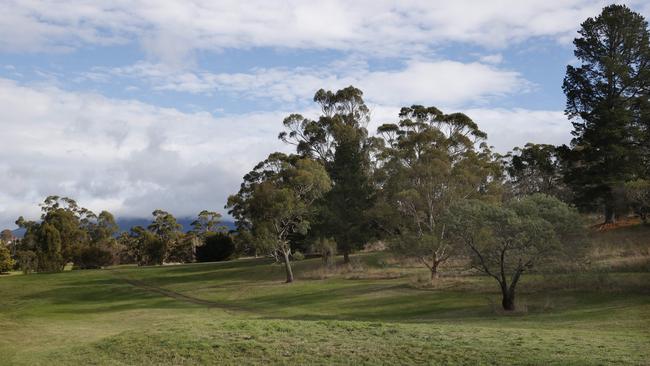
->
<box><xmin>0</xmin><ymin>0</ymin><xmax>650</xmax><ymax>229</ymax></box>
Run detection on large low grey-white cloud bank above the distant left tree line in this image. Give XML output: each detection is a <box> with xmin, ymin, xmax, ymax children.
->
<box><xmin>0</xmin><ymin>79</ymin><xmax>287</xmax><ymax>227</ymax></box>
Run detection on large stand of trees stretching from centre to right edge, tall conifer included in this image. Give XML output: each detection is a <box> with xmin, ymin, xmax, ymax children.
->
<box><xmin>226</xmin><ymin>5</ymin><xmax>650</xmax><ymax>310</ymax></box>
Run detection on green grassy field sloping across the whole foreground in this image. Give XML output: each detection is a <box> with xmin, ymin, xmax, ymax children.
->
<box><xmin>0</xmin><ymin>228</ymin><xmax>650</xmax><ymax>365</ymax></box>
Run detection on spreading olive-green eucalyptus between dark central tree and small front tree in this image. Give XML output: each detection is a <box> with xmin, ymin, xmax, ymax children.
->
<box><xmin>375</xmin><ymin>105</ymin><xmax>500</xmax><ymax>281</ymax></box>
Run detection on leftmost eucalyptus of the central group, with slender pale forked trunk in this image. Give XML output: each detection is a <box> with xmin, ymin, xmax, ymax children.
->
<box><xmin>226</xmin><ymin>153</ymin><xmax>331</xmax><ymax>283</ymax></box>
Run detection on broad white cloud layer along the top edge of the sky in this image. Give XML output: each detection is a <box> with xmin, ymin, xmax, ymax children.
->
<box><xmin>0</xmin><ymin>0</ymin><xmax>650</xmax><ymax>63</ymax></box>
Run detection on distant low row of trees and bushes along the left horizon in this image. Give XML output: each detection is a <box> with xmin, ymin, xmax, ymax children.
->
<box><xmin>7</xmin><ymin>196</ymin><xmax>235</xmax><ymax>273</ymax></box>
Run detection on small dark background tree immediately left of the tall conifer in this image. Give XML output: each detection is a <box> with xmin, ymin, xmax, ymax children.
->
<box><xmin>503</xmin><ymin>143</ymin><xmax>570</xmax><ymax>200</ymax></box>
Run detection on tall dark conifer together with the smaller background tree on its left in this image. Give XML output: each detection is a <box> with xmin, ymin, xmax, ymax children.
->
<box><xmin>507</xmin><ymin>5</ymin><xmax>650</xmax><ymax>224</ymax></box>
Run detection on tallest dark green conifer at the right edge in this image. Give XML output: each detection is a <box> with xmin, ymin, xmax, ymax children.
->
<box><xmin>562</xmin><ymin>5</ymin><xmax>650</xmax><ymax>223</ymax></box>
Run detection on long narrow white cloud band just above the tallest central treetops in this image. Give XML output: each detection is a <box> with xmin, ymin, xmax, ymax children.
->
<box><xmin>98</xmin><ymin>60</ymin><xmax>532</xmax><ymax>106</ymax></box>
